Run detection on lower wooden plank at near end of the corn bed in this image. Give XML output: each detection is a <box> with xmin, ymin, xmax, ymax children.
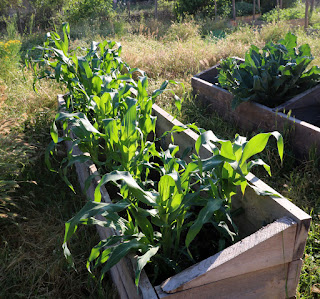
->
<box><xmin>156</xmin><ymin>264</ymin><xmax>292</xmax><ymax>299</ymax></box>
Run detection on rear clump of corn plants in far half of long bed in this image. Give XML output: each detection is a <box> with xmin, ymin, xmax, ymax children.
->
<box><xmin>33</xmin><ymin>23</ymin><xmax>181</xmax><ymax>189</ymax></box>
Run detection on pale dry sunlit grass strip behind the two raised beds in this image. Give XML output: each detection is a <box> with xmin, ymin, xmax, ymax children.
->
<box><xmin>117</xmin><ymin>23</ymin><xmax>320</xmax><ymax>79</ymax></box>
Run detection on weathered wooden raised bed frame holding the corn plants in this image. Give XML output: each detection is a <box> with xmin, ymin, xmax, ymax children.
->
<box><xmin>59</xmin><ymin>97</ymin><xmax>310</xmax><ymax>299</ymax></box>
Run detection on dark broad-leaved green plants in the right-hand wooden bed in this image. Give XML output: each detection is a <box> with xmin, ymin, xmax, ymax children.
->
<box><xmin>218</xmin><ymin>33</ymin><xmax>320</xmax><ymax>109</ymax></box>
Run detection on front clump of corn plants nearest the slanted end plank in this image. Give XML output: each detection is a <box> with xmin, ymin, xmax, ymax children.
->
<box><xmin>64</xmin><ymin>126</ymin><xmax>283</xmax><ymax>285</ymax></box>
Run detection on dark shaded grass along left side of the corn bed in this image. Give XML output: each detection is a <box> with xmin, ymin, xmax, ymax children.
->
<box><xmin>0</xmin><ymin>114</ymin><xmax>117</xmax><ymax>298</ymax></box>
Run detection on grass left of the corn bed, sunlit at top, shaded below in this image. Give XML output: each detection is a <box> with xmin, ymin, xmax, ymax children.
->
<box><xmin>0</xmin><ymin>61</ymin><xmax>116</xmax><ymax>298</ymax></box>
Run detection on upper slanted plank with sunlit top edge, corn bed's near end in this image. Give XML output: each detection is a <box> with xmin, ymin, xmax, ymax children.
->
<box><xmin>161</xmin><ymin>217</ymin><xmax>297</xmax><ymax>293</ymax></box>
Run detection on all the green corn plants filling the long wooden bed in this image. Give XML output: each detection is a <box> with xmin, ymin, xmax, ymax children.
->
<box><xmin>31</xmin><ymin>25</ymin><xmax>283</xmax><ymax>286</ymax></box>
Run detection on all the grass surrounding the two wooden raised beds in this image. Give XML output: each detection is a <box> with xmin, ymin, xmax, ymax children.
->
<box><xmin>0</xmin><ymin>15</ymin><xmax>320</xmax><ymax>298</ymax></box>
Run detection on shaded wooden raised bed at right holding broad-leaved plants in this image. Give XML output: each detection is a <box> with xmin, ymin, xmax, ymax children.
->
<box><xmin>191</xmin><ymin>64</ymin><xmax>320</xmax><ymax>155</ymax></box>
